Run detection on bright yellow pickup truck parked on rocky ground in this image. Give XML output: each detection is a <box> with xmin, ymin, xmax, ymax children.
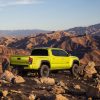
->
<box><xmin>10</xmin><ymin>48</ymin><xmax>79</xmax><ymax>77</ymax></box>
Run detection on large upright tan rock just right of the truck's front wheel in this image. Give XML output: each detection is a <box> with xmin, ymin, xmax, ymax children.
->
<box><xmin>84</xmin><ymin>62</ymin><xmax>97</xmax><ymax>78</ymax></box>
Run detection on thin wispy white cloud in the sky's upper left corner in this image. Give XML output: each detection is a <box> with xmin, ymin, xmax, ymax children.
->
<box><xmin>0</xmin><ymin>0</ymin><xmax>43</xmax><ymax>8</ymax></box>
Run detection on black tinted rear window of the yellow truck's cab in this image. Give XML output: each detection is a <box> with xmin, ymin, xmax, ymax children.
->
<box><xmin>31</xmin><ymin>49</ymin><xmax>48</xmax><ymax>56</ymax></box>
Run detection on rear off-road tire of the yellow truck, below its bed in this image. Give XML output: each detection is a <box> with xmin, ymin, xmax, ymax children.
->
<box><xmin>38</xmin><ymin>65</ymin><xmax>50</xmax><ymax>77</ymax></box>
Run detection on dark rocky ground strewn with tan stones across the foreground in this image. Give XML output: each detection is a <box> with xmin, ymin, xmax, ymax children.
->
<box><xmin>0</xmin><ymin>68</ymin><xmax>100</xmax><ymax>100</ymax></box>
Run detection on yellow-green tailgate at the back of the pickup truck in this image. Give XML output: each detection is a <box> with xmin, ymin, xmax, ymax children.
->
<box><xmin>10</xmin><ymin>56</ymin><xmax>29</xmax><ymax>65</ymax></box>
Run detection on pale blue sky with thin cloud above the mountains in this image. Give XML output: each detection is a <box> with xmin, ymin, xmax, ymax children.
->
<box><xmin>0</xmin><ymin>0</ymin><xmax>100</xmax><ymax>31</ymax></box>
